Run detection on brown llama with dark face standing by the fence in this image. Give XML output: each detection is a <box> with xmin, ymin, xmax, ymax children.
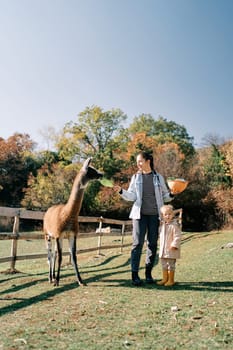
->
<box><xmin>43</xmin><ymin>158</ymin><xmax>103</xmax><ymax>286</ymax></box>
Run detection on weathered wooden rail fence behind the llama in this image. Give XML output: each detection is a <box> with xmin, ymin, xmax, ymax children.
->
<box><xmin>0</xmin><ymin>207</ymin><xmax>132</xmax><ymax>273</ymax></box>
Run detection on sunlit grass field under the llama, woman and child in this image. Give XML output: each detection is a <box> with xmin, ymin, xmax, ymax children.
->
<box><xmin>0</xmin><ymin>231</ymin><xmax>233</xmax><ymax>350</ymax></box>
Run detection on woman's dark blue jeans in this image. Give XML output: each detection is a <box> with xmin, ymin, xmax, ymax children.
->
<box><xmin>131</xmin><ymin>215</ymin><xmax>159</xmax><ymax>272</ymax></box>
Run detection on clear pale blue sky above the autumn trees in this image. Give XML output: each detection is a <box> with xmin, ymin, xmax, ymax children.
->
<box><xmin>0</xmin><ymin>0</ymin><xmax>233</xmax><ymax>146</ymax></box>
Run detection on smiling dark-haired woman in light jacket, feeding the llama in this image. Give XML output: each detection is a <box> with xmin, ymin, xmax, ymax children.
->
<box><xmin>114</xmin><ymin>152</ymin><xmax>176</xmax><ymax>286</ymax></box>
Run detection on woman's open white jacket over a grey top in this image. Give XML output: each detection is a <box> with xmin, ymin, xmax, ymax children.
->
<box><xmin>121</xmin><ymin>172</ymin><xmax>173</xmax><ymax>219</ymax></box>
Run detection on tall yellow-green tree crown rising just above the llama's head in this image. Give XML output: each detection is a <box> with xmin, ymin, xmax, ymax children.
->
<box><xmin>56</xmin><ymin>106</ymin><xmax>127</xmax><ymax>176</ymax></box>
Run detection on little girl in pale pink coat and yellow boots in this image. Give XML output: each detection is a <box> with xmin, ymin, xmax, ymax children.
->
<box><xmin>157</xmin><ymin>204</ymin><xmax>181</xmax><ymax>286</ymax></box>
